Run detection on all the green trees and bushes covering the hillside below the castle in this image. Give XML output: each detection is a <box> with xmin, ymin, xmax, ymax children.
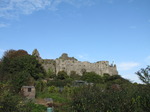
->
<box><xmin>0</xmin><ymin>50</ymin><xmax>150</xmax><ymax>112</ymax></box>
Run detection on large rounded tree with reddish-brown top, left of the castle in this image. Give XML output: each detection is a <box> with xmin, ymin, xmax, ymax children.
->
<box><xmin>0</xmin><ymin>50</ymin><xmax>45</xmax><ymax>93</ymax></box>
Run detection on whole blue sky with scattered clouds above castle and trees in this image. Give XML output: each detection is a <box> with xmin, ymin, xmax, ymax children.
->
<box><xmin>0</xmin><ymin>0</ymin><xmax>150</xmax><ymax>82</ymax></box>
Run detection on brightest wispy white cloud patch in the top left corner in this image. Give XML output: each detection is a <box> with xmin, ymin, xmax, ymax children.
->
<box><xmin>0</xmin><ymin>0</ymin><xmax>51</xmax><ymax>18</ymax></box>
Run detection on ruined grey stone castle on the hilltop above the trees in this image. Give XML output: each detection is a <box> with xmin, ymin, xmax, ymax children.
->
<box><xmin>32</xmin><ymin>49</ymin><xmax>118</xmax><ymax>75</ymax></box>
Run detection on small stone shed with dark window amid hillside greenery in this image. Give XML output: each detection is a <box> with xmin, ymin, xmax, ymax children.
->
<box><xmin>21</xmin><ymin>86</ymin><xmax>35</xmax><ymax>99</ymax></box>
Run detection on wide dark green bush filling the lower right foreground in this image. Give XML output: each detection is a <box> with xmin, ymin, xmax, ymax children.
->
<box><xmin>71</xmin><ymin>85</ymin><xmax>150</xmax><ymax>112</ymax></box>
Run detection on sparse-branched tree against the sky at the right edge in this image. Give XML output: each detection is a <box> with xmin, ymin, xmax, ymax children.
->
<box><xmin>136</xmin><ymin>66</ymin><xmax>150</xmax><ymax>84</ymax></box>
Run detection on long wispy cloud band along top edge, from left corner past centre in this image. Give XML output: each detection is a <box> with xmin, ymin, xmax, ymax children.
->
<box><xmin>0</xmin><ymin>0</ymin><xmax>94</xmax><ymax>18</ymax></box>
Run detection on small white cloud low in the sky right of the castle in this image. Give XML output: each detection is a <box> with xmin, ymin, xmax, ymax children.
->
<box><xmin>118</xmin><ymin>62</ymin><xmax>140</xmax><ymax>71</ymax></box>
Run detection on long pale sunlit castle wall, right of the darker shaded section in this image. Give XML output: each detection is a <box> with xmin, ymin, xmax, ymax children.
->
<box><xmin>56</xmin><ymin>59</ymin><xmax>118</xmax><ymax>75</ymax></box>
